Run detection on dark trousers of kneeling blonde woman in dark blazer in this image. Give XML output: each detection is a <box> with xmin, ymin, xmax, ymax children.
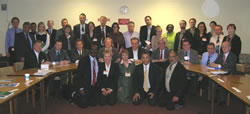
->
<box><xmin>100</xmin><ymin>91</ymin><xmax>116</xmax><ymax>105</ymax></box>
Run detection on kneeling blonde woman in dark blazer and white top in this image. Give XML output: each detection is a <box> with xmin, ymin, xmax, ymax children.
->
<box><xmin>97</xmin><ymin>50</ymin><xmax>119</xmax><ymax>105</ymax></box>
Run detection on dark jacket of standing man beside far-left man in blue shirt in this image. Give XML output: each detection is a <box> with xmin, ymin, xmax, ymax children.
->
<box><xmin>14</xmin><ymin>32</ymin><xmax>35</xmax><ymax>62</ymax></box>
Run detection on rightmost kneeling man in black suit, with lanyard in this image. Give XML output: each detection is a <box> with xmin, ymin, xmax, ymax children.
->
<box><xmin>158</xmin><ymin>51</ymin><xmax>187</xmax><ymax>110</ymax></box>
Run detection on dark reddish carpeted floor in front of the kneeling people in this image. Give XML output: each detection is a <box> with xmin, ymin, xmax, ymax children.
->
<box><xmin>0</xmin><ymin>91</ymin><xmax>245</xmax><ymax>114</ymax></box>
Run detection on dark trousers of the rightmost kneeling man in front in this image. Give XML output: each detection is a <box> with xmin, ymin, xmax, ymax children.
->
<box><xmin>158</xmin><ymin>91</ymin><xmax>184</xmax><ymax>110</ymax></box>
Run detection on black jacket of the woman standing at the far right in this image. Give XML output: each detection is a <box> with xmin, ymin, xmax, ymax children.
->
<box><xmin>224</xmin><ymin>34</ymin><xmax>241</xmax><ymax>63</ymax></box>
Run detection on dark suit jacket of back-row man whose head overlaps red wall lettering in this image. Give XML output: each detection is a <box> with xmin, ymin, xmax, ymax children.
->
<box><xmin>95</xmin><ymin>25</ymin><xmax>113</xmax><ymax>48</ymax></box>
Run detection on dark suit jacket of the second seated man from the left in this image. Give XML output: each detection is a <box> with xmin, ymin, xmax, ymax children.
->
<box><xmin>48</xmin><ymin>48</ymin><xmax>70</xmax><ymax>62</ymax></box>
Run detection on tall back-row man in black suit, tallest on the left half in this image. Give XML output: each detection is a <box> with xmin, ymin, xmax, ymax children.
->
<box><xmin>73</xmin><ymin>13</ymin><xmax>89</xmax><ymax>39</ymax></box>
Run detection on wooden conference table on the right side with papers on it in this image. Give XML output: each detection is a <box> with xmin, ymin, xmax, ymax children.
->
<box><xmin>184</xmin><ymin>64</ymin><xmax>250</xmax><ymax>114</ymax></box>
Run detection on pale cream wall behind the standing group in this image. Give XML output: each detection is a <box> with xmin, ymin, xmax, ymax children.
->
<box><xmin>0</xmin><ymin>0</ymin><xmax>250</xmax><ymax>53</ymax></box>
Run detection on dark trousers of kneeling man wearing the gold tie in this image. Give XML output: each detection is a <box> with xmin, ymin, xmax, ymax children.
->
<box><xmin>133</xmin><ymin>91</ymin><xmax>157</xmax><ymax>105</ymax></box>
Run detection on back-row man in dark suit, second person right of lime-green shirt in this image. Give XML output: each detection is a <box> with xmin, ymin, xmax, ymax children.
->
<box><xmin>187</xmin><ymin>18</ymin><xmax>199</xmax><ymax>51</ymax></box>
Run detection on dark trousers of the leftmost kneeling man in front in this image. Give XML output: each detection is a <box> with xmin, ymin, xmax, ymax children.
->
<box><xmin>73</xmin><ymin>87</ymin><xmax>99</xmax><ymax>108</ymax></box>
